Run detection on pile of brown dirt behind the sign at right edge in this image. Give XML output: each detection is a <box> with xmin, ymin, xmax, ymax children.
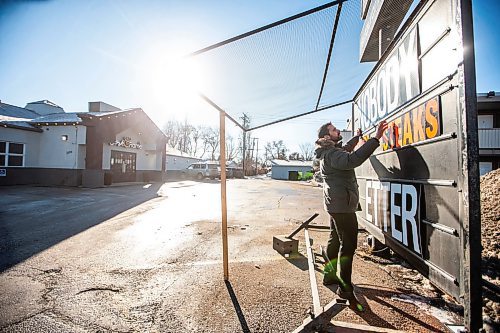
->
<box><xmin>481</xmin><ymin>169</ymin><xmax>500</xmax><ymax>328</ymax></box>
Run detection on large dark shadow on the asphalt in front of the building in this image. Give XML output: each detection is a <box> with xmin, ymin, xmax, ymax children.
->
<box><xmin>0</xmin><ymin>183</ymin><xmax>163</xmax><ymax>272</ymax></box>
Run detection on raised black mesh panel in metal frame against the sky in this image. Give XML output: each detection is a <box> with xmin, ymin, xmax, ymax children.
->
<box><xmin>189</xmin><ymin>0</ymin><xmax>373</xmax><ymax>130</ymax></box>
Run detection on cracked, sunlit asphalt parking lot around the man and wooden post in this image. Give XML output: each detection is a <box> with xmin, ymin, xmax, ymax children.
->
<box><xmin>0</xmin><ymin>178</ymin><xmax>460</xmax><ymax>332</ymax></box>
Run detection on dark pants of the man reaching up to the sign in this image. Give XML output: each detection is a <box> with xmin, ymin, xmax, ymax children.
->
<box><xmin>326</xmin><ymin>213</ymin><xmax>358</xmax><ymax>291</ymax></box>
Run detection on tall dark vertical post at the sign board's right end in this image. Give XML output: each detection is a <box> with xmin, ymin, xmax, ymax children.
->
<box><xmin>456</xmin><ymin>0</ymin><xmax>482</xmax><ymax>332</ymax></box>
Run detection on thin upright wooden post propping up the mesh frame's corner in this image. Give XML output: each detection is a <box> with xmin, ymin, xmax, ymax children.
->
<box><xmin>219</xmin><ymin>111</ymin><xmax>229</xmax><ymax>281</ymax></box>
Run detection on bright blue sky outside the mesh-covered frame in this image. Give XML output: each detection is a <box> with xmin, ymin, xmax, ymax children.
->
<box><xmin>0</xmin><ymin>0</ymin><xmax>500</xmax><ymax>152</ymax></box>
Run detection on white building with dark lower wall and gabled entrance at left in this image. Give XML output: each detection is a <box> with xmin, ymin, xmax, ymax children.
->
<box><xmin>0</xmin><ymin>100</ymin><xmax>165</xmax><ymax>187</ymax></box>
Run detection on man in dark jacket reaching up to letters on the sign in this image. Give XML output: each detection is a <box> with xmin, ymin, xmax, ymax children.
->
<box><xmin>315</xmin><ymin>121</ymin><xmax>387</xmax><ymax>311</ymax></box>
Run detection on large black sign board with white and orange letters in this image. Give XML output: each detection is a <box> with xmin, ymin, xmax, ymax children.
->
<box><xmin>352</xmin><ymin>0</ymin><xmax>481</xmax><ymax>331</ymax></box>
